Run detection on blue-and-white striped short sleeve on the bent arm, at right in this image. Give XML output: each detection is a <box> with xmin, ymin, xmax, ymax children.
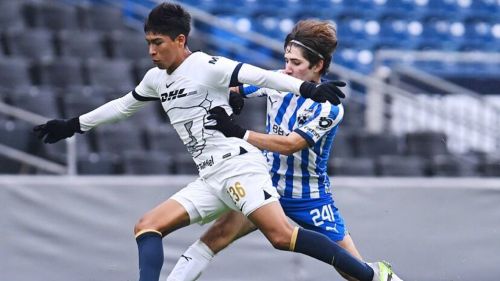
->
<box><xmin>294</xmin><ymin>103</ymin><xmax>344</xmax><ymax>146</ymax></box>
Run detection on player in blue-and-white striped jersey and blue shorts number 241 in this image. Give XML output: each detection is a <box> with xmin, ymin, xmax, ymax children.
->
<box><xmin>167</xmin><ymin>20</ymin><xmax>400</xmax><ymax>281</ymax></box>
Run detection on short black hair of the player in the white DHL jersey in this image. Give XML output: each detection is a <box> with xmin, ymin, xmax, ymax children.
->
<box><xmin>144</xmin><ymin>2</ymin><xmax>191</xmax><ymax>43</ymax></box>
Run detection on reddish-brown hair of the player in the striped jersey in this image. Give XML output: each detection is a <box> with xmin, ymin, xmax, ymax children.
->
<box><xmin>284</xmin><ymin>19</ymin><xmax>337</xmax><ymax>75</ymax></box>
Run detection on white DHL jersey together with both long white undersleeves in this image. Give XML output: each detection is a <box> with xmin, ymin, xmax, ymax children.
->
<box><xmin>79</xmin><ymin>52</ymin><xmax>310</xmax><ymax>176</ymax></box>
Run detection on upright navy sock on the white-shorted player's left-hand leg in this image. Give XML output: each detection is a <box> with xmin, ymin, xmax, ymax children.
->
<box><xmin>135</xmin><ymin>229</ymin><xmax>163</xmax><ymax>281</ymax></box>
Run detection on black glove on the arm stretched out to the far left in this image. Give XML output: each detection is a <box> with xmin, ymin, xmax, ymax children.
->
<box><xmin>33</xmin><ymin>117</ymin><xmax>83</xmax><ymax>143</ymax></box>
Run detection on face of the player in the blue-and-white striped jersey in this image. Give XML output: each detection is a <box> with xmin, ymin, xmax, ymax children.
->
<box><xmin>285</xmin><ymin>45</ymin><xmax>321</xmax><ymax>82</ymax></box>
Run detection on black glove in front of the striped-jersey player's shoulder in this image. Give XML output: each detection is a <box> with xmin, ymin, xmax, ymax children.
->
<box><xmin>300</xmin><ymin>81</ymin><xmax>346</xmax><ymax>105</ymax></box>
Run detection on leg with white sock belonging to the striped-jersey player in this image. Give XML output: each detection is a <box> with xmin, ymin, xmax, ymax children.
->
<box><xmin>167</xmin><ymin>211</ymin><xmax>256</xmax><ymax>281</ymax></box>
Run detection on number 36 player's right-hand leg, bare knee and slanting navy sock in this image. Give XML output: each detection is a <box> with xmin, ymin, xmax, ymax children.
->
<box><xmin>248</xmin><ymin>202</ymin><xmax>374</xmax><ymax>281</ymax></box>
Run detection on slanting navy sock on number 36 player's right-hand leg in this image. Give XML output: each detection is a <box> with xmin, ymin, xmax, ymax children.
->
<box><xmin>290</xmin><ymin>227</ymin><xmax>374</xmax><ymax>281</ymax></box>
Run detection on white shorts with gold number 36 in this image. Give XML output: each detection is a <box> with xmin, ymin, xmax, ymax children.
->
<box><xmin>171</xmin><ymin>152</ymin><xmax>279</xmax><ymax>224</ymax></box>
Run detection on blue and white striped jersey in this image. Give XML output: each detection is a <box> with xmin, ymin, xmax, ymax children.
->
<box><xmin>241</xmin><ymin>86</ymin><xmax>344</xmax><ymax>199</ymax></box>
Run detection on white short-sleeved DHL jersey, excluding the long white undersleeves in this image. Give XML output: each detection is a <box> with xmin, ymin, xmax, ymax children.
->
<box><xmin>133</xmin><ymin>52</ymin><xmax>258</xmax><ymax>175</ymax></box>
